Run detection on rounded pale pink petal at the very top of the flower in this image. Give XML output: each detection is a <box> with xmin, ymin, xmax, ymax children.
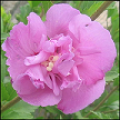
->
<box><xmin>45</xmin><ymin>4</ymin><xmax>80</xmax><ymax>38</ymax></box>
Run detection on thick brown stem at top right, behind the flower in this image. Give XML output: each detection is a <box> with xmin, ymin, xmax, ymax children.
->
<box><xmin>91</xmin><ymin>1</ymin><xmax>114</xmax><ymax>20</ymax></box>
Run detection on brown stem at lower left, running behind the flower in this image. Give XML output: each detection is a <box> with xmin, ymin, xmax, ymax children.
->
<box><xmin>1</xmin><ymin>96</ymin><xmax>21</xmax><ymax>113</ymax></box>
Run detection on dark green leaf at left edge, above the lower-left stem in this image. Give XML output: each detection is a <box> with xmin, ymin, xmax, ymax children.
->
<box><xmin>1</xmin><ymin>81</ymin><xmax>9</xmax><ymax>101</ymax></box>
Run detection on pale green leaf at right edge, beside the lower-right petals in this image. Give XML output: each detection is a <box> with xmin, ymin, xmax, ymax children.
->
<box><xmin>105</xmin><ymin>71</ymin><xmax>119</xmax><ymax>81</ymax></box>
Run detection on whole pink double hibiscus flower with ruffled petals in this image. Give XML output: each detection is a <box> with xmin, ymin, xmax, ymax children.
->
<box><xmin>2</xmin><ymin>4</ymin><xmax>116</xmax><ymax>114</ymax></box>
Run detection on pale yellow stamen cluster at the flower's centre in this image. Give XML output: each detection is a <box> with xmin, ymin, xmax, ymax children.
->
<box><xmin>41</xmin><ymin>55</ymin><xmax>59</xmax><ymax>71</ymax></box>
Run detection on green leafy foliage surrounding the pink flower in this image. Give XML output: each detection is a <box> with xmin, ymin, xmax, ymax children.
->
<box><xmin>1</xmin><ymin>1</ymin><xmax>119</xmax><ymax>119</ymax></box>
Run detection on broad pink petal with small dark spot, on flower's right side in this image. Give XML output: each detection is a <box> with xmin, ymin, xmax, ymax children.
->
<box><xmin>69</xmin><ymin>14</ymin><xmax>116</xmax><ymax>85</ymax></box>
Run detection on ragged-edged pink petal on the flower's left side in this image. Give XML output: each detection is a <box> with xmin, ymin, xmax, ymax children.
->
<box><xmin>2</xmin><ymin>13</ymin><xmax>46</xmax><ymax>80</ymax></box>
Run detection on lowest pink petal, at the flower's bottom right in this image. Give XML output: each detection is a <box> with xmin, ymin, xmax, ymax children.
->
<box><xmin>58</xmin><ymin>80</ymin><xmax>105</xmax><ymax>114</ymax></box>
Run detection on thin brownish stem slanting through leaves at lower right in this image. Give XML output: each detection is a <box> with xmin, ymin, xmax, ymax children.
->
<box><xmin>85</xmin><ymin>86</ymin><xmax>119</xmax><ymax>117</ymax></box>
